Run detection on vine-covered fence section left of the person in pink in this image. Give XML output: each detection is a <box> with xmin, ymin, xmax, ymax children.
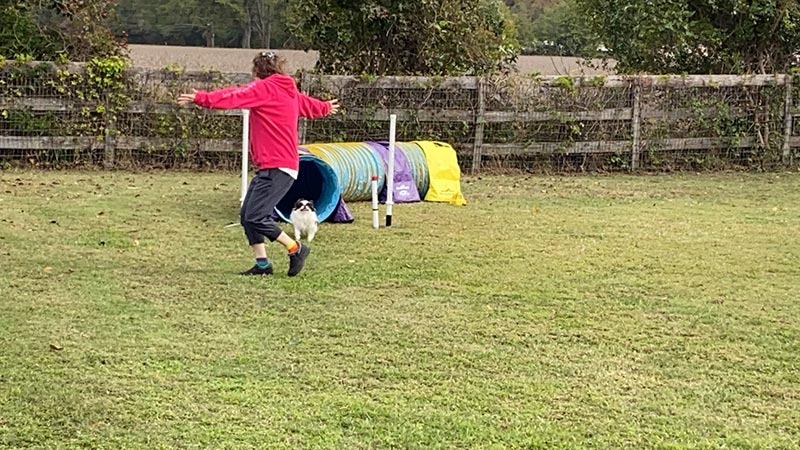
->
<box><xmin>0</xmin><ymin>63</ymin><xmax>246</xmax><ymax>168</ymax></box>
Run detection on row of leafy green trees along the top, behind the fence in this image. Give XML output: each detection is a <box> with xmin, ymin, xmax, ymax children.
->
<box><xmin>0</xmin><ymin>0</ymin><xmax>800</xmax><ymax>75</ymax></box>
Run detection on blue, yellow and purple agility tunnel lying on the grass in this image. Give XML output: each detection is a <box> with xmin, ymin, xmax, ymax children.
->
<box><xmin>275</xmin><ymin>141</ymin><xmax>466</xmax><ymax>223</ymax></box>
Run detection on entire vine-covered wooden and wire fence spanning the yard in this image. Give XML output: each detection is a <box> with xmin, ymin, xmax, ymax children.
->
<box><xmin>0</xmin><ymin>59</ymin><xmax>800</xmax><ymax>172</ymax></box>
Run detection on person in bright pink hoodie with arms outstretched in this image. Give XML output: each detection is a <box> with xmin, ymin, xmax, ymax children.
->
<box><xmin>178</xmin><ymin>52</ymin><xmax>339</xmax><ymax>277</ymax></box>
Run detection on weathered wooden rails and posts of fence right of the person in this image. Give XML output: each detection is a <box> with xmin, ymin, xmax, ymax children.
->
<box><xmin>300</xmin><ymin>74</ymin><xmax>800</xmax><ymax>173</ymax></box>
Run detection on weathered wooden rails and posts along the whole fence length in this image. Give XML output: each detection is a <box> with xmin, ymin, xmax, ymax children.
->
<box><xmin>0</xmin><ymin>69</ymin><xmax>800</xmax><ymax>173</ymax></box>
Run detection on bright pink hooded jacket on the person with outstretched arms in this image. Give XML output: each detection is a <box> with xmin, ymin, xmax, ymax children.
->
<box><xmin>194</xmin><ymin>74</ymin><xmax>331</xmax><ymax>170</ymax></box>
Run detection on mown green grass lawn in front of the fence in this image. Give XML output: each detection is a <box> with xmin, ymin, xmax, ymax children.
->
<box><xmin>0</xmin><ymin>171</ymin><xmax>800</xmax><ymax>449</ymax></box>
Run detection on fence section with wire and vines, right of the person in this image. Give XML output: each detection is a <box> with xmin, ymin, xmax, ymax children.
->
<box><xmin>303</xmin><ymin>75</ymin><xmax>800</xmax><ymax>172</ymax></box>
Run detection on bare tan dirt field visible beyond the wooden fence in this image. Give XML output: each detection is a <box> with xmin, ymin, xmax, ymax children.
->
<box><xmin>128</xmin><ymin>44</ymin><xmax>609</xmax><ymax>75</ymax></box>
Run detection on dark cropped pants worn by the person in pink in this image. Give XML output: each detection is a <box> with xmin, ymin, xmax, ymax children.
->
<box><xmin>240</xmin><ymin>169</ymin><xmax>294</xmax><ymax>245</ymax></box>
